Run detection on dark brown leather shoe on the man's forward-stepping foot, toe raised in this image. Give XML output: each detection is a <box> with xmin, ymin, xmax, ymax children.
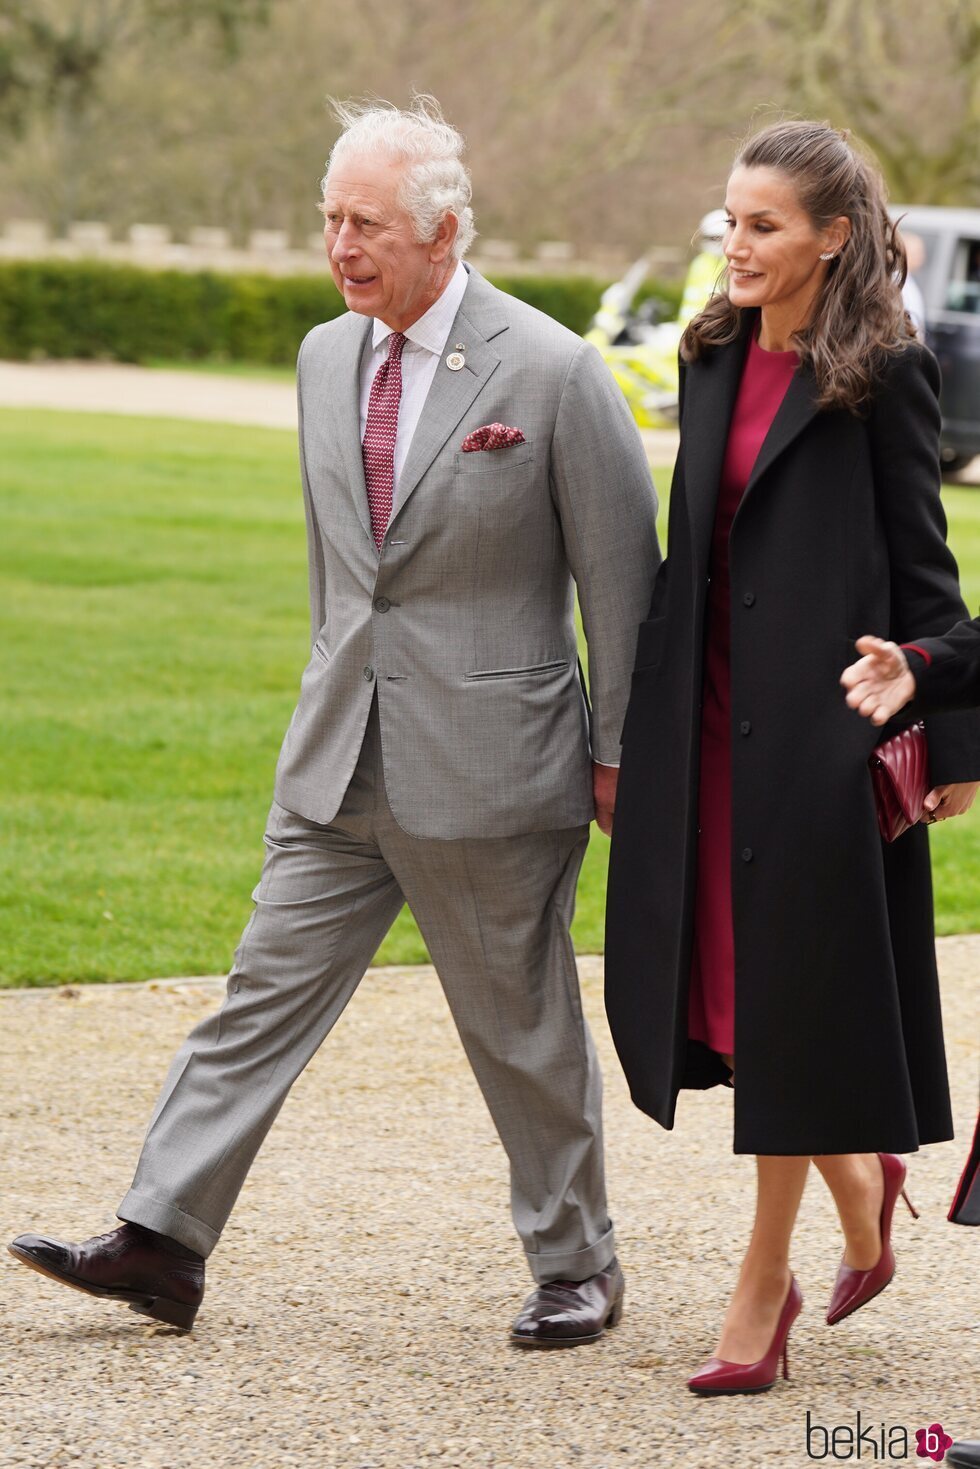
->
<box><xmin>7</xmin><ymin>1224</ymin><xmax>204</xmax><ymax>1331</ymax></box>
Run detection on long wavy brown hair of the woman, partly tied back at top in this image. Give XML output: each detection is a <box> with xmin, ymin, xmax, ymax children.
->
<box><xmin>680</xmin><ymin>122</ymin><xmax>915</xmax><ymax>413</ymax></box>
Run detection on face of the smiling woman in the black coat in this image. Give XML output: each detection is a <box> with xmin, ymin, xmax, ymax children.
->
<box><xmin>723</xmin><ymin>167</ymin><xmax>849</xmax><ymax>328</ymax></box>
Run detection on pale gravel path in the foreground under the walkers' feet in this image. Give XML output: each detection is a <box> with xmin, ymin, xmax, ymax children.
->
<box><xmin>0</xmin><ymin>937</ymin><xmax>980</xmax><ymax>1469</ymax></box>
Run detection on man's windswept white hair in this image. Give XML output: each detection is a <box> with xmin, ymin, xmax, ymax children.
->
<box><xmin>322</xmin><ymin>94</ymin><xmax>476</xmax><ymax>260</ymax></box>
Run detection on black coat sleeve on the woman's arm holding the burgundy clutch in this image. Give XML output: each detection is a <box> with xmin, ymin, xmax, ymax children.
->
<box><xmin>868</xmin><ymin>344</ymin><xmax>980</xmax><ymax>784</ymax></box>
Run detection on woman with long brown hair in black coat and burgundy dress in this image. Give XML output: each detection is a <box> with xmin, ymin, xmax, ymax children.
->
<box><xmin>605</xmin><ymin>122</ymin><xmax>980</xmax><ymax>1393</ymax></box>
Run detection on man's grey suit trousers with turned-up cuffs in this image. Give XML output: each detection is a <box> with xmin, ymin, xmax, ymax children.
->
<box><xmin>118</xmin><ymin>704</ymin><xmax>614</xmax><ymax>1282</ymax></box>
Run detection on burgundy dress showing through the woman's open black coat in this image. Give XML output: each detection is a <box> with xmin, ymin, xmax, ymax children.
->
<box><xmin>688</xmin><ymin>338</ymin><xmax>798</xmax><ymax>1055</ymax></box>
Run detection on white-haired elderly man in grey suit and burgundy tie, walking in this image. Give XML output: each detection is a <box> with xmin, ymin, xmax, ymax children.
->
<box><xmin>10</xmin><ymin>98</ymin><xmax>660</xmax><ymax>1346</ymax></box>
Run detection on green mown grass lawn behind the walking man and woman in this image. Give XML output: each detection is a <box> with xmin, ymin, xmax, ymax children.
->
<box><xmin>0</xmin><ymin>411</ymin><xmax>980</xmax><ymax>984</ymax></box>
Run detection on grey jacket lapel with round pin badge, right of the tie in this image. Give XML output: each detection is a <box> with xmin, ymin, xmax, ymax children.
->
<box><xmin>391</xmin><ymin>270</ymin><xmax>507</xmax><ymax>521</ymax></box>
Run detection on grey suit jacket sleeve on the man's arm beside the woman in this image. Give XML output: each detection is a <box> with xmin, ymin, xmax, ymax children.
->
<box><xmin>551</xmin><ymin>342</ymin><xmax>660</xmax><ymax>765</ymax></box>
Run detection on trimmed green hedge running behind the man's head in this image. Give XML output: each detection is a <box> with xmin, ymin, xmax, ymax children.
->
<box><xmin>0</xmin><ymin>260</ymin><xmax>674</xmax><ymax>364</ymax></box>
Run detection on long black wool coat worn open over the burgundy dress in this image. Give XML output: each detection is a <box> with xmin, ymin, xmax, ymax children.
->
<box><xmin>605</xmin><ymin>311</ymin><xmax>980</xmax><ymax>1155</ymax></box>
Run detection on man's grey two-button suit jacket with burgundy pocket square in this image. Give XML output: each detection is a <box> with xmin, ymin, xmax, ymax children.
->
<box><xmin>276</xmin><ymin>270</ymin><xmax>660</xmax><ymax>839</ymax></box>
